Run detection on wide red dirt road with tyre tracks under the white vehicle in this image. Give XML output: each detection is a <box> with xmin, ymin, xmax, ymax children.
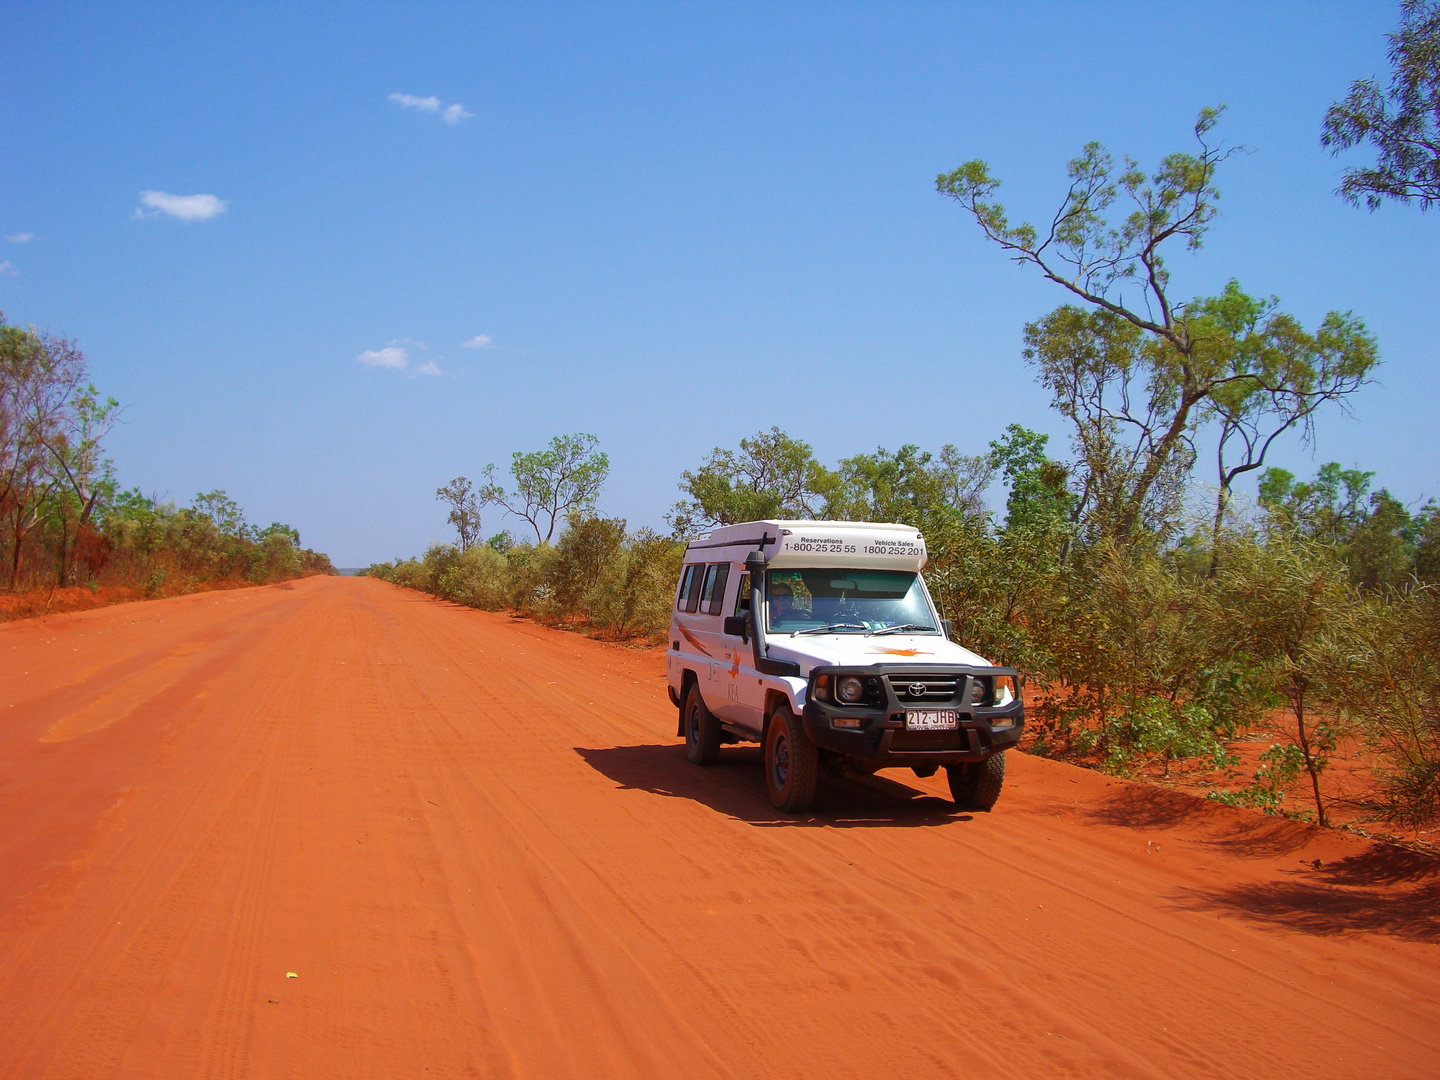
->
<box><xmin>0</xmin><ymin>577</ymin><xmax>1440</xmax><ymax>1080</ymax></box>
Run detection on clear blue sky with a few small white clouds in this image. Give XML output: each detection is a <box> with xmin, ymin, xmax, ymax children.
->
<box><xmin>0</xmin><ymin>0</ymin><xmax>1440</xmax><ymax>564</ymax></box>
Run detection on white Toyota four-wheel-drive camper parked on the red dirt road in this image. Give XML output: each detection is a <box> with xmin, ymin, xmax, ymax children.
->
<box><xmin>665</xmin><ymin>521</ymin><xmax>1025</xmax><ymax>814</ymax></box>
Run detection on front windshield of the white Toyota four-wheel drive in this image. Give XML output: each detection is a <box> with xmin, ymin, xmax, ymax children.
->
<box><xmin>766</xmin><ymin>569</ymin><xmax>939</xmax><ymax>634</ymax></box>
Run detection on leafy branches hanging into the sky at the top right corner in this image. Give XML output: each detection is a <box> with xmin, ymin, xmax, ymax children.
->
<box><xmin>1320</xmin><ymin>0</ymin><xmax>1440</xmax><ymax>210</ymax></box>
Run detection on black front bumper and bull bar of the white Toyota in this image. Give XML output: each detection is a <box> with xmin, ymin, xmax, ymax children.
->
<box><xmin>801</xmin><ymin>664</ymin><xmax>1025</xmax><ymax>768</ymax></box>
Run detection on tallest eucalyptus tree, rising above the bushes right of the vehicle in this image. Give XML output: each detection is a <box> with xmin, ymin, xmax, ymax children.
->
<box><xmin>936</xmin><ymin>108</ymin><xmax>1377</xmax><ymax>550</ymax></box>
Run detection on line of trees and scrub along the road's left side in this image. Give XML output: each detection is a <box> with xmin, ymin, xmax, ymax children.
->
<box><xmin>0</xmin><ymin>317</ymin><xmax>333</xmax><ymax>610</ymax></box>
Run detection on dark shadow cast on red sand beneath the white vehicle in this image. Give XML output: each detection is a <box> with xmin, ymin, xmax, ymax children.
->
<box><xmin>575</xmin><ymin>743</ymin><xmax>972</xmax><ymax>828</ymax></box>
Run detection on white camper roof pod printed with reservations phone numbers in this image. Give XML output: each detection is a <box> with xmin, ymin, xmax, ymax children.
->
<box><xmin>690</xmin><ymin>521</ymin><xmax>926</xmax><ymax>572</ymax></box>
